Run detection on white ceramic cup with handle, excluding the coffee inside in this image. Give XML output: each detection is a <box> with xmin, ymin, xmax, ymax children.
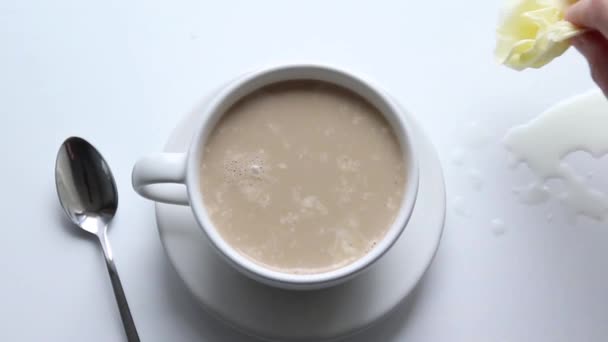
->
<box><xmin>132</xmin><ymin>64</ymin><xmax>418</xmax><ymax>290</ymax></box>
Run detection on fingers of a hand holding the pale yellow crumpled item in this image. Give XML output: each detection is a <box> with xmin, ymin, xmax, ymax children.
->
<box><xmin>566</xmin><ymin>0</ymin><xmax>608</xmax><ymax>96</ymax></box>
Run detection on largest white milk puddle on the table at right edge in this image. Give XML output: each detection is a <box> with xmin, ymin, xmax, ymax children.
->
<box><xmin>504</xmin><ymin>91</ymin><xmax>608</xmax><ymax>221</ymax></box>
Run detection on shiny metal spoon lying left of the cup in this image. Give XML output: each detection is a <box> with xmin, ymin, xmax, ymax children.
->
<box><xmin>55</xmin><ymin>137</ymin><xmax>139</xmax><ymax>342</ymax></box>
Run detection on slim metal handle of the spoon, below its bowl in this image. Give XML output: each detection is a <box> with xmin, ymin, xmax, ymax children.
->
<box><xmin>99</xmin><ymin>232</ymin><xmax>139</xmax><ymax>342</ymax></box>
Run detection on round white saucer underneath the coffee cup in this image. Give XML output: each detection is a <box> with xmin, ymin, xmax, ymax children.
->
<box><xmin>156</xmin><ymin>89</ymin><xmax>445</xmax><ymax>341</ymax></box>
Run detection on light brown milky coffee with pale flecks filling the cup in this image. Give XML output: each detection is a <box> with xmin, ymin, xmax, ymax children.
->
<box><xmin>201</xmin><ymin>81</ymin><xmax>406</xmax><ymax>274</ymax></box>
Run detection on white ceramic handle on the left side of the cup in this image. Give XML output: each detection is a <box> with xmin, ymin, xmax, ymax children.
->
<box><xmin>131</xmin><ymin>153</ymin><xmax>190</xmax><ymax>205</ymax></box>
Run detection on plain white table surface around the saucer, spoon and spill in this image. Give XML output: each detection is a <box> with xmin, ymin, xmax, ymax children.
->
<box><xmin>0</xmin><ymin>0</ymin><xmax>608</xmax><ymax>342</ymax></box>
